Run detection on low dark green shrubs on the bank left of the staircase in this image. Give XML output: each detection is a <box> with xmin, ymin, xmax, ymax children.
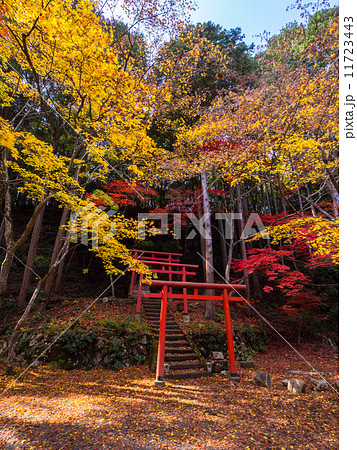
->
<box><xmin>0</xmin><ymin>316</ymin><xmax>151</xmax><ymax>370</ymax></box>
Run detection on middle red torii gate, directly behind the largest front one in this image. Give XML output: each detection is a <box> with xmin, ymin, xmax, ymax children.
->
<box><xmin>136</xmin><ymin>259</ymin><xmax>198</xmax><ymax>315</ymax></box>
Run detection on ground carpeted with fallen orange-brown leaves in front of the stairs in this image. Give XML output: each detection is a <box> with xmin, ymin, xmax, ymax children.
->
<box><xmin>0</xmin><ymin>344</ymin><xmax>338</xmax><ymax>450</ymax></box>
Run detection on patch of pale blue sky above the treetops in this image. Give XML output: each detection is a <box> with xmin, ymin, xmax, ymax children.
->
<box><xmin>192</xmin><ymin>0</ymin><xmax>338</xmax><ymax>49</ymax></box>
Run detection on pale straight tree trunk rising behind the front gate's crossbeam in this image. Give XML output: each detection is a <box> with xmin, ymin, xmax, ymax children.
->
<box><xmin>201</xmin><ymin>173</ymin><xmax>215</xmax><ymax>320</ymax></box>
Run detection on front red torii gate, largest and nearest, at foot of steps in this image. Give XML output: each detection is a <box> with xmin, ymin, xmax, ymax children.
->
<box><xmin>140</xmin><ymin>280</ymin><xmax>247</xmax><ymax>386</ymax></box>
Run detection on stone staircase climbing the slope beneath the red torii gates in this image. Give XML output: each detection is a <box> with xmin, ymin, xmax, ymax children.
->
<box><xmin>142</xmin><ymin>298</ymin><xmax>208</xmax><ymax>380</ymax></box>
